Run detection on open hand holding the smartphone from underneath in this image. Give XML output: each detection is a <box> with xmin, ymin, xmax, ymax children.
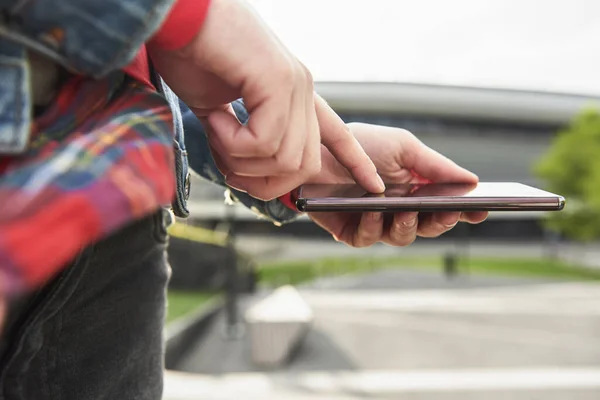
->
<box><xmin>309</xmin><ymin>124</ymin><xmax>487</xmax><ymax>247</ymax></box>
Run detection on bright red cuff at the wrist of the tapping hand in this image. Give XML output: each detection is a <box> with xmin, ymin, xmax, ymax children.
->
<box><xmin>150</xmin><ymin>0</ymin><xmax>210</xmax><ymax>51</ymax></box>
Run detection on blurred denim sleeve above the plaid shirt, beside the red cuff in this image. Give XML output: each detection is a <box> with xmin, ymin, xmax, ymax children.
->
<box><xmin>0</xmin><ymin>0</ymin><xmax>175</xmax><ymax>77</ymax></box>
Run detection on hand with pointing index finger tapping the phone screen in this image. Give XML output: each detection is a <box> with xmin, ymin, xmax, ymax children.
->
<box><xmin>149</xmin><ymin>0</ymin><xmax>383</xmax><ymax>200</ymax></box>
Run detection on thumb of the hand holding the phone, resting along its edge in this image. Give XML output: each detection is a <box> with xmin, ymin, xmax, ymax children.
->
<box><xmin>403</xmin><ymin>136</ymin><xmax>479</xmax><ymax>183</ymax></box>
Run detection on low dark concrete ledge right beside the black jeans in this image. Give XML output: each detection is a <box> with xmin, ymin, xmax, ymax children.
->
<box><xmin>165</xmin><ymin>296</ymin><xmax>223</xmax><ymax>369</ymax></box>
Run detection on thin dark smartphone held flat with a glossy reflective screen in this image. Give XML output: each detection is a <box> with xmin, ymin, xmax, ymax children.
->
<box><xmin>295</xmin><ymin>182</ymin><xmax>565</xmax><ymax>212</ymax></box>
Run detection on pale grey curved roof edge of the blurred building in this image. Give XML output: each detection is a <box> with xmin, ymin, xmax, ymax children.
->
<box><xmin>316</xmin><ymin>82</ymin><xmax>600</xmax><ymax>125</ymax></box>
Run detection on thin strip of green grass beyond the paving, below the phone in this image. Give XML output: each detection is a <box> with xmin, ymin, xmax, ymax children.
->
<box><xmin>259</xmin><ymin>257</ymin><xmax>600</xmax><ymax>286</ymax></box>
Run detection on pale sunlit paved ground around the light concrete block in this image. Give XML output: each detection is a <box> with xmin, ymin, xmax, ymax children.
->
<box><xmin>166</xmin><ymin>271</ymin><xmax>600</xmax><ymax>400</ymax></box>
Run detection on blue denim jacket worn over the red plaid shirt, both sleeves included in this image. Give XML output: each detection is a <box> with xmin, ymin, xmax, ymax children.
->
<box><xmin>0</xmin><ymin>0</ymin><xmax>295</xmax><ymax>224</ymax></box>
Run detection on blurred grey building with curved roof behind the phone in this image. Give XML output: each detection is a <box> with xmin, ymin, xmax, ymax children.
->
<box><xmin>317</xmin><ymin>82</ymin><xmax>600</xmax><ymax>185</ymax></box>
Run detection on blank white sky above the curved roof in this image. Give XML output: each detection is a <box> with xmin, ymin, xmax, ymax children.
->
<box><xmin>252</xmin><ymin>0</ymin><xmax>600</xmax><ymax>95</ymax></box>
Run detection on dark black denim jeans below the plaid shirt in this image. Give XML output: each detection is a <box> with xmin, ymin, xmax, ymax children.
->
<box><xmin>0</xmin><ymin>210</ymin><xmax>170</xmax><ymax>400</ymax></box>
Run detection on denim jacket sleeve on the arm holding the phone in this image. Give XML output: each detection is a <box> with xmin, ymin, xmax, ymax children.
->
<box><xmin>180</xmin><ymin>101</ymin><xmax>298</xmax><ymax>225</ymax></box>
